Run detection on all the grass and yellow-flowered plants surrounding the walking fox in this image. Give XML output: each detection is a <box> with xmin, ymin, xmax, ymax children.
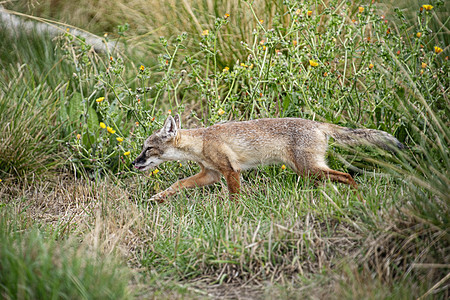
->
<box><xmin>0</xmin><ymin>1</ymin><xmax>450</xmax><ymax>299</ymax></box>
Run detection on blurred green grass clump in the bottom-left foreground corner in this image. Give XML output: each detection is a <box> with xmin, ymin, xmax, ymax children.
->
<box><xmin>0</xmin><ymin>208</ymin><xmax>131</xmax><ymax>299</ymax></box>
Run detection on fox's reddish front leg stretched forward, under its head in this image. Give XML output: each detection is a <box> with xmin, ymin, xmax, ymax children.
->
<box><xmin>150</xmin><ymin>166</ymin><xmax>220</xmax><ymax>202</ymax></box>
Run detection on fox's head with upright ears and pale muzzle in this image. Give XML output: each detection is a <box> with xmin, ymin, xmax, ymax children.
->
<box><xmin>132</xmin><ymin>114</ymin><xmax>181</xmax><ymax>171</ymax></box>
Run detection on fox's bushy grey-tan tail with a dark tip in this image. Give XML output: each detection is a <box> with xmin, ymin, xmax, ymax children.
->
<box><xmin>324</xmin><ymin>124</ymin><xmax>405</xmax><ymax>151</ymax></box>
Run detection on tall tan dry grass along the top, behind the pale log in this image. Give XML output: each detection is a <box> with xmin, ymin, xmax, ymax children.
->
<box><xmin>6</xmin><ymin>0</ymin><xmax>284</xmax><ymax>66</ymax></box>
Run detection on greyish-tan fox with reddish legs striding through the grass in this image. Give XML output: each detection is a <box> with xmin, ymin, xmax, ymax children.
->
<box><xmin>132</xmin><ymin>114</ymin><xmax>404</xmax><ymax>202</ymax></box>
